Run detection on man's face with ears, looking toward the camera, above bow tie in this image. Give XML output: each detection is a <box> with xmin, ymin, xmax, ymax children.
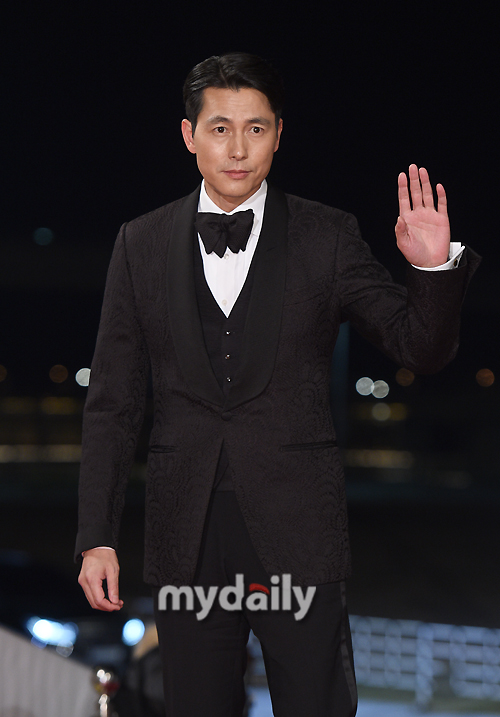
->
<box><xmin>182</xmin><ymin>87</ymin><xmax>283</xmax><ymax>212</ymax></box>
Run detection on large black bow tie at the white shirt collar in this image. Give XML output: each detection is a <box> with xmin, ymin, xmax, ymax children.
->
<box><xmin>194</xmin><ymin>209</ymin><xmax>253</xmax><ymax>259</ymax></box>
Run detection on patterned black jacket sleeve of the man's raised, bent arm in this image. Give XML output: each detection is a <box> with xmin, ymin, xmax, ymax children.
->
<box><xmin>337</xmin><ymin>214</ymin><xmax>480</xmax><ymax>373</ymax></box>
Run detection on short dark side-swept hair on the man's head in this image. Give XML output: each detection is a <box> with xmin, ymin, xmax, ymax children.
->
<box><xmin>183</xmin><ymin>52</ymin><xmax>285</xmax><ymax>134</ymax></box>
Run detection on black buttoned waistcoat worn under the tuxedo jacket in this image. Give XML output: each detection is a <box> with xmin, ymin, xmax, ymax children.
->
<box><xmin>194</xmin><ymin>236</ymin><xmax>255</xmax><ymax>490</ymax></box>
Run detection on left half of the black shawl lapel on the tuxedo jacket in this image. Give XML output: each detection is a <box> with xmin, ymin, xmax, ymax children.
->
<box><xmin>167</xmin><ymin>187</ymin><xmax>224</xmax><ymax>406</ymax></box>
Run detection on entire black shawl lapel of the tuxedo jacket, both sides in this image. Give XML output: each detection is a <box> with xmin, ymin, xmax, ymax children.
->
<box><xmin>167</xmin><ymin>186</ymin><xmax>288</xmax><ymax>411</ymax></box>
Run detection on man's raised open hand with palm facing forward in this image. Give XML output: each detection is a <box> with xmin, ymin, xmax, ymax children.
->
<box><xmin>396</xmin><ymin>164</ymin><xmax>450</xmax><ymax>268</ymax></box>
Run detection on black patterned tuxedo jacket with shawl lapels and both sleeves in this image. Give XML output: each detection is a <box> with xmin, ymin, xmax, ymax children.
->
<box><xmin>76</xmin><ymin>187</ymin><xmax>478</xmax><ymax>585</ymax></box>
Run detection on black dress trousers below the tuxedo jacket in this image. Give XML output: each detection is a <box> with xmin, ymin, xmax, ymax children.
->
<box><xmin>153</xmin><ymin>491</ymin><xmax>357</xmax><ymax>717</ymax></box>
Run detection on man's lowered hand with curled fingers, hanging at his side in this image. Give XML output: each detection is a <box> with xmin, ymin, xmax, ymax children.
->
<box><xmin>78</xmin><ymin>548</ymin><xmax>123</xmax><ymax>612</ymax></box>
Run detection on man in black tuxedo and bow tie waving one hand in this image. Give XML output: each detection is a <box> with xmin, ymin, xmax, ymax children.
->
<box><xmin>76</xmin><ymin>53</ymin><xmax>478</xmax><ymax>717</ymax></box>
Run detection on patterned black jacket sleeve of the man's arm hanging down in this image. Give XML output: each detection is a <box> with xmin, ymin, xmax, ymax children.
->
<box><xmin>75</xmin><ymin>224</ymin><xmax>149</xmax><ymax>559</ymax></box>
